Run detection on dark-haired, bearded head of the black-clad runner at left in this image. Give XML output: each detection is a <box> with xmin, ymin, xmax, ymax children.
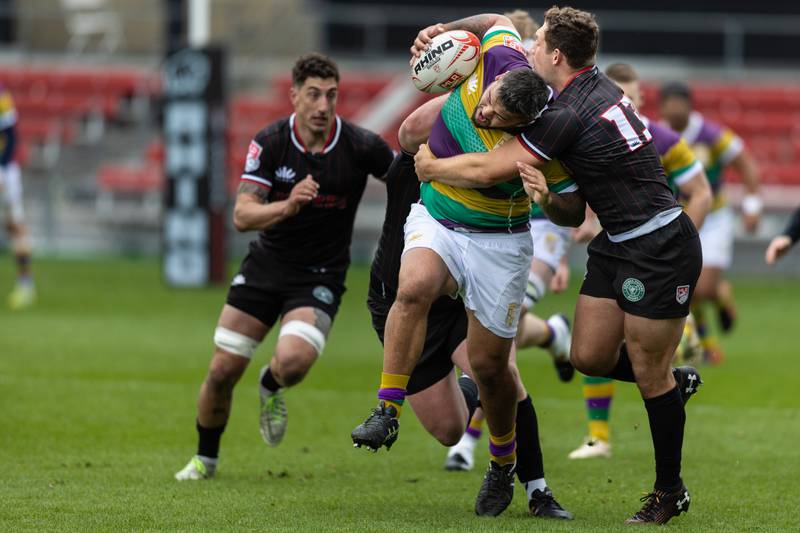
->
<box><xmin>290</xmin><ymin>54</ymin><xmax>339</xmax><ymax>133</ymax></box>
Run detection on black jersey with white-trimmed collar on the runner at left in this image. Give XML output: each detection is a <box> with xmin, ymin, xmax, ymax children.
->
<box><xmin>242</xmin><ymin>115</ymin><xmax>393</xmax><ymax>273</ymax></box>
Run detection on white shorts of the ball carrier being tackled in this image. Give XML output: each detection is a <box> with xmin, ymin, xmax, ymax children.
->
<box><xmin>403</xmin><ymin>204</ymin><xmax>533</xmax><ymax>339</ymax></box>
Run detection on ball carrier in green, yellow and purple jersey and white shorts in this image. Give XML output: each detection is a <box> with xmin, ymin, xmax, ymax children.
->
<box><xmin>352</xmin><ymin>15</ymin><xmax>570</xmax><ymax>516</ymax></box>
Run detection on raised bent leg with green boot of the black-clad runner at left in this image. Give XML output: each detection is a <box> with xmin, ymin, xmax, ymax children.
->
<box><xmin>259</xmin><ymin>304</ymin><xmax>330</xmax><ymax>446</ymax></box>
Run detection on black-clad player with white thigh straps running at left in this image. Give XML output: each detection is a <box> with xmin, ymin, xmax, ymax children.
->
<box><xmin>175</xmin><ymin>54</ymin><xmax>394</xmax><ymax>480</ymax></box>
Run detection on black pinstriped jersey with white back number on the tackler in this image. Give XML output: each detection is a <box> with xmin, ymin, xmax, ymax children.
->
<box><xmin>518</xmin><ymin>67</ymin><xmax>678</xmax><ymax>234</ymax></box>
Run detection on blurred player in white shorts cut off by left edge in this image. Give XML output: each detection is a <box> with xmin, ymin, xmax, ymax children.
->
<box><xmin>0</xmin><ymin>85</ymin><xmax>36</xmax><ymax>309</ymax></box>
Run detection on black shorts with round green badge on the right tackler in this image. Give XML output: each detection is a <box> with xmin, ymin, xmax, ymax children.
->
<box><xmin>581</xmin><ymin>213</ymin><xmax>703</xmax><ymax>319</ymax></box>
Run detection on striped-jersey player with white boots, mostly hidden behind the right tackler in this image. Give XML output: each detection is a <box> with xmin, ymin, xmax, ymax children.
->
<box><xmin>569</xmin><ymin>63</ymin><xmax>711</xmax><ymax>459</ymax></box>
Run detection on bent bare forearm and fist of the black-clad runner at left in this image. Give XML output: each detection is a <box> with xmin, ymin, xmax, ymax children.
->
<box><xmin>233</xmin><ymin>174</ymin><xmax>319</xmax><ymax>232</ymax></box>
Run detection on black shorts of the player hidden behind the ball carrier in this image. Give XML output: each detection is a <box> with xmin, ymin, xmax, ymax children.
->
<box><xmin>367</xmin><ymin>276</ymin><xmax>467</xmax><ymax>394</ymax></box>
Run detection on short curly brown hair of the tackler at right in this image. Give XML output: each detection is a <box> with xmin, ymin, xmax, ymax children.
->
<box><xmin>544</xmin><ymin>6</ymin><xmax>600</xmax><ymax>68</ymax></box>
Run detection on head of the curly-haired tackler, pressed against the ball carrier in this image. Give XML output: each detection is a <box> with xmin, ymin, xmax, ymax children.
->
<box><xmin>533</xmin><ymin>6</ymin><xmax>600</xmax><ymax>84</ymax></box>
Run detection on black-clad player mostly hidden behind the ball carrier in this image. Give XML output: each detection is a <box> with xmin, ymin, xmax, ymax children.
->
<box><xmin>367</xmin><ymin>150</ymin><xmax>572</xmax><ymax>519</ymax></box>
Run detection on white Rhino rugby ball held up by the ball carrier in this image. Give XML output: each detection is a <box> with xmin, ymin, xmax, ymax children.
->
<box><xmin>411</xmin><ymin>30</ymin><xmax>481</xmax><ymax>94</ymax></box>
